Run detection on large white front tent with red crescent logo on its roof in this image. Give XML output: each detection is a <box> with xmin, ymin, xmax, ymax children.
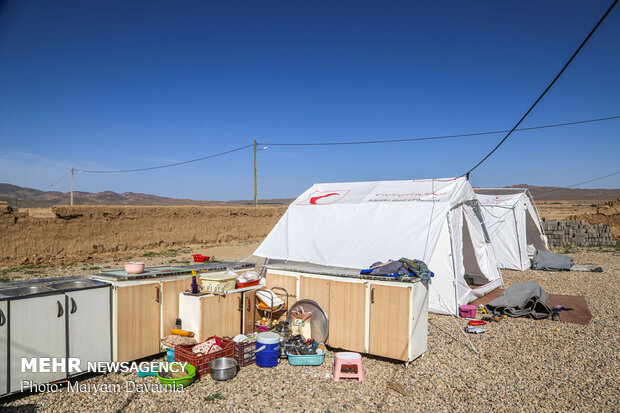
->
<box><xmin>254</xmin><ymin>178</ymin><xmax>503</xmax><ymax>314</ymax></box>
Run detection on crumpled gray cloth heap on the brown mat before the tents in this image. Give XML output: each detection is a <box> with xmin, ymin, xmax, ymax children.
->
<box><xmin>486</xmin><ymin>281</ymin><xmax>551</xmax><ymax>319</ymax></box>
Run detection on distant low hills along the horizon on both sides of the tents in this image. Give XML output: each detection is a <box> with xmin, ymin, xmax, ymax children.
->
<box><xmin>0</xmin><ymin>183</ymin><xmax>620</xmax><ymax>208</ymax></box>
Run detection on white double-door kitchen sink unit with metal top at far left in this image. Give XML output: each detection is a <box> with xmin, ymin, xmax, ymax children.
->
<box><xmin>0</xmin><ymin>277</ymin><xmax>112</xmax><ymax>396</ymax></box>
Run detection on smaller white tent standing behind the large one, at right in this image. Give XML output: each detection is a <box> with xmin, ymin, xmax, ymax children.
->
<box><xmin>476</xmin><ymin>188</ymin><xmax>548</xmax><ymax>271</ymax></box>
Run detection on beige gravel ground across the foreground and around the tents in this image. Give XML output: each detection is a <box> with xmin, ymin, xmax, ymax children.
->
<box><xmin>0</xmin><ymin>246</ymin><xmax>620</xmax><ymax>412</ymax></box>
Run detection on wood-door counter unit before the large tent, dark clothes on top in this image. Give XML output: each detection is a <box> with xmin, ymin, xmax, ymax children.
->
<box><xmin>263</xmin><ymin>262</ymin><xmax>428</xmax><ymax>363</ymax></box>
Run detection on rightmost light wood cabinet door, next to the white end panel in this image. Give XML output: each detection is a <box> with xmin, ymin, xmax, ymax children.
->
<box><xmin>368</xmin><ymin>284</ymin><xmax>411</xmax><ymax>360</ymax></box>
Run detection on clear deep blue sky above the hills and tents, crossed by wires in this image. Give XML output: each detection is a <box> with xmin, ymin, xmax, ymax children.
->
<box><xmin>0</xmin><ymin>0</ymin><xmax>620</xmax><ymax>200</ymax></box>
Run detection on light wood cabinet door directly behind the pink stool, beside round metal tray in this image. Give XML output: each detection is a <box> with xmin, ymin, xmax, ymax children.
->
<box><xmin>327</xmin><ymin>281</ymin><xmax>366</xmax><ymax>353</ymax></box>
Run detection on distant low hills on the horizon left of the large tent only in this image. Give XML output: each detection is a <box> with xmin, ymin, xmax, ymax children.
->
<box><xmin>0</xmin><ymin>183</ymin><xmax>292</xmax><ymax>208</ymax></box>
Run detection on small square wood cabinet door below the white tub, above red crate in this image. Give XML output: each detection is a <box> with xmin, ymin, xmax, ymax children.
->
<box><xmin>200</xmin><ymin>293</ymin><xmax>243</xmax><ymax>341</ymax></box>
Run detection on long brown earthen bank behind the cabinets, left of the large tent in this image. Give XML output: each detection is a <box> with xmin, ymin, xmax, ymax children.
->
<box><xmin>0</xmin><ymin>206</ymin><xmax>285</xmax><ymax>265</ymax></box>
